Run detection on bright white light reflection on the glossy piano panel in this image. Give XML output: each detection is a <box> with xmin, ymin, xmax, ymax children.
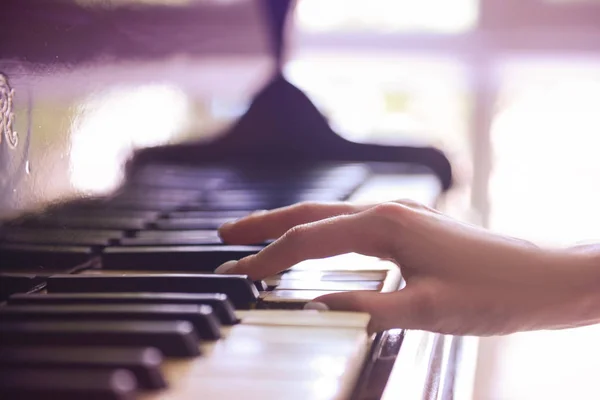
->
<box><xmin>70</xmin><ymin>84</ymin><xmax>189</xmax><ymax>194</ymax></box>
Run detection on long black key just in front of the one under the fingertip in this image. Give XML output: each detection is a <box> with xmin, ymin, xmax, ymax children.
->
<box><xmin>46</xmin><ymin>274</ymin><xmax>259</xmax><ymax>309</ymax></box>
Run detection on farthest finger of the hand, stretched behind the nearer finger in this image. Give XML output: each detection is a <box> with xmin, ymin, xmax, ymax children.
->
<box><xmin>219</xmin><ymin>202</ymin><xmax>371</xmax><ymax>244</ymax></box>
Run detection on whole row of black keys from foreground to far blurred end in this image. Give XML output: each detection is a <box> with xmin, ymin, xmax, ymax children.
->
<box><xmin>0</xmin><ymin>168</ymin><xmax>365</xmax><ymax>400</ymax></box>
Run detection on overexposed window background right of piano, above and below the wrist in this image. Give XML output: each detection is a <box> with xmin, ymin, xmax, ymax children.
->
<box><xmin>287</xmin><ymin>0</ymin><xmax>600</xmax><ymax>400</ymax></box>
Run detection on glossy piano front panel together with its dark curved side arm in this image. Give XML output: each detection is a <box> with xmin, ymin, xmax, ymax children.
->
<box><xmin>0</xmin><ymin>0</ymin><xmax>451</xmax><ymax>217</ymax></box>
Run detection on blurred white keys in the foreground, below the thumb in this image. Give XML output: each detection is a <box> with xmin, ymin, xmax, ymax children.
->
<box><xmin>140</xmin><ymin>310</ymin><xmax>371</xmax><ymax>400</ymax></box>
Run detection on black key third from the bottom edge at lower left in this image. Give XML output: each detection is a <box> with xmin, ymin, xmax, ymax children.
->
<box><xmin>0</xmin><ymin>320</ymin><xmax>200</xmax><ymax>357</ymax></box>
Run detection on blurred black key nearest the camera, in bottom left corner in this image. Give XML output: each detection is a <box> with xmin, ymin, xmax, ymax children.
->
<box><xmin>0</xmin><ymin>368</ymin><xmax>137</xmax><ymax>400</ymax></box>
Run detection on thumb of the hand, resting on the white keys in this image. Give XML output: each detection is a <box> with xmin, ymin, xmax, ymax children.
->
<box><xmin>313</xmin><ymin>287</ymin><xmax>422</xmax><ymax>333</ymax></box>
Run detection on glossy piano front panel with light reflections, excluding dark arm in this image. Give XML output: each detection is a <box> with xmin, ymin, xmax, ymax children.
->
<box><xmin>0</xmin><ymin>0</ymin><xmax>275</xmax><ymax>215</ymax></box>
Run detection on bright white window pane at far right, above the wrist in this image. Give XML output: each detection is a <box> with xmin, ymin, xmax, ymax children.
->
<box><xmin>489</xmin><ymin>58</ymin><xmax>600</xmax><ymax>245</ymax></box>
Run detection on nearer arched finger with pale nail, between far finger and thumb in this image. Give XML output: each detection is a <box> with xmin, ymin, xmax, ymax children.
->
<box><xmin>215</xmin><ymin>204</ymin><xmax>406</xmax><ymax>280</ymax></box>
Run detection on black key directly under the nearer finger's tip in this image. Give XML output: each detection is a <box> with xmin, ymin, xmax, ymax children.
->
<box><xmin>101</xmin><ymin>246</ymin><xmax>263</xmax><ymax>272</ymax></box>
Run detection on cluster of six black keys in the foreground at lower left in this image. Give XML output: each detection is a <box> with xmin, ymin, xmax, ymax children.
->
<box><xmin>0</xmin><ymin>275</ymin><xmax>258</xmax><ymax>400</ymax></box>
